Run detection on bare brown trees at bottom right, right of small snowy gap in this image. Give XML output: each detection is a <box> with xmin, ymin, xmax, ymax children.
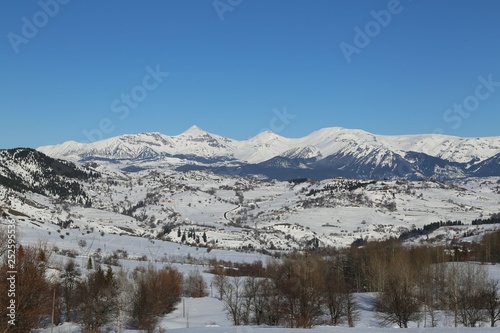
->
<box><xmin>345</xmin><ymin>236</ymin><xmax>500</xmax><ymax>327</ymax></box>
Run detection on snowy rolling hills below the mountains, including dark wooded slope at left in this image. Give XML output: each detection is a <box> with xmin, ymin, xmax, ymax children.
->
<box><xmin>0</xmin><ymin>150</ymin><xmax>500</xmax><ymax>250</ymax></box>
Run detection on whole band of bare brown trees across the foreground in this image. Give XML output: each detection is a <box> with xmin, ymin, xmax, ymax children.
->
<box><xmin>0</xmin><ymin>229</ymin><xmax>500</xmax><ymax>332</ymax></box>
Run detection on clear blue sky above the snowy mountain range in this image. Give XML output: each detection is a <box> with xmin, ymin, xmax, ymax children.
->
<box><xmin>0</xmin><ymin>0</ymin><xmax>500</xmax><ymax>148</ymax></box>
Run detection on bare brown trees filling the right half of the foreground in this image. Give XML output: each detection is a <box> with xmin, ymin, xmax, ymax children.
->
<box><xmin>216</xmin><ymin>235</ymin><xmax>500</xmax><ymax>327</ymax></box>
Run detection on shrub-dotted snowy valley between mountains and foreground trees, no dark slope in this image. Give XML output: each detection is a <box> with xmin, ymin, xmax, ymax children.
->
<box><xmin>5</xmin><ymin>172</ymin><xmax>500</xmax><ymax>252</ymax></box>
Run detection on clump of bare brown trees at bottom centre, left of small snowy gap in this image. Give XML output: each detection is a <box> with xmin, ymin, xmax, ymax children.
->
<box><xmin>212</xmin><ymin>255</ymin><xmax>358</xmax><ymax>328</ymax></box>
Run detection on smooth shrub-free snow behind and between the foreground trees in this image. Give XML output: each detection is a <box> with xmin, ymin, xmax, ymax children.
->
<box><xmin>11</xmin><ymin>214</ymin><xmax>500</xmax><ymax>333</ymax></box>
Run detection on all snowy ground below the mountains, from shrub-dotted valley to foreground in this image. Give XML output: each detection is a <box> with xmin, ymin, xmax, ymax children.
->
<box><xmin>5</xmin><ymin>171</ymin><xmax>500</xmax><ymax>333</ymax></box>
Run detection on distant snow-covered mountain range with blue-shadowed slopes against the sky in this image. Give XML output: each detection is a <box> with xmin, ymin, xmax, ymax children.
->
<box><xmin>38</xmin><ymin>126</ymin><xmax>500</xmax><ymax>179</ymax></box>
